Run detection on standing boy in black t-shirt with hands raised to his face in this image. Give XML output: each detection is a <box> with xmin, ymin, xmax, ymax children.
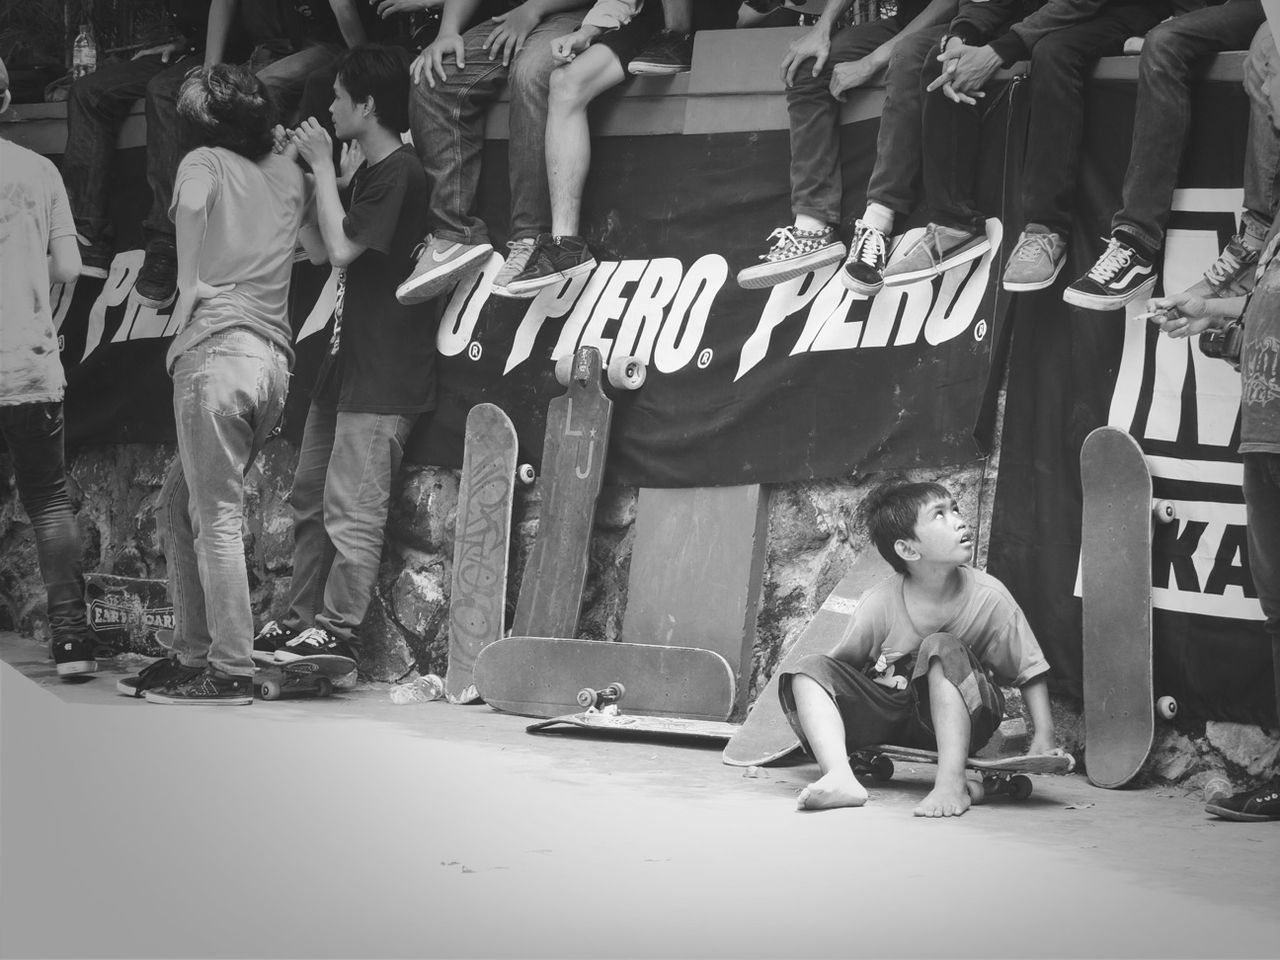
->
<box><xmin>253</xmin><ymin>45</ymin><xmax>439</xmax><ymax>660</ymax></box>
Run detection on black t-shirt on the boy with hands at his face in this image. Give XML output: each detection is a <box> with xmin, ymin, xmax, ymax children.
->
<box><xmin>315</xmin><ymin>146</ymin><xmax>439</xmax><ymax>413</ymax></box>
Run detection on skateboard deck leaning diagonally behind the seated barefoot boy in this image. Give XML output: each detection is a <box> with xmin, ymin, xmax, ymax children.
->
<box><xmin>721</xmin><ymin>550</ymin><xmax>893</xmax><ymax>767</ymax></box>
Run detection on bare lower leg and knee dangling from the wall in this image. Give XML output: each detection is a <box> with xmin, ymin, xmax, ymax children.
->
<box><xmin>547</xmin><ymin>45</ymin><xmax>627</xmax><ymax>237</ymax></box>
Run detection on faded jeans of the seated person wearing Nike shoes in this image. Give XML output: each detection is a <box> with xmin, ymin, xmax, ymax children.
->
<box><xmin>410</xmin><ymin>10</ymin><xmax>582</xmax><ymax>243</ymax></box>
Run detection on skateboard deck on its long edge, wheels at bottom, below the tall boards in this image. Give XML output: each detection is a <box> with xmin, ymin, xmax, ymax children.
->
<box><xmin>475</xmin><ymin>636</ymin><xmax>733</xmax><ymax>721</ymax></box>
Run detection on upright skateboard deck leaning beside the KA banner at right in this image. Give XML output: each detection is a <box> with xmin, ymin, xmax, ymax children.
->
<box><xmin>1080</xmin><ymin>426</ymin><xmax>1156</xmax><ymax>787</ymax></box>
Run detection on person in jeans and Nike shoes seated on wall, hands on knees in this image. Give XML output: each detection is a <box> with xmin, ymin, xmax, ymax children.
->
<box><xmin>396</xmin><ymin>0</ymin><xmax>586</xmax><ymax>303</ymax></box>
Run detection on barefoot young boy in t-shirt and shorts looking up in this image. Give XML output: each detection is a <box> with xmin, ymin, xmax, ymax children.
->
<box><xmin>778</xmin><ymin>483</ymin><xmax>1060</xmax><ymax>817</ymax></box>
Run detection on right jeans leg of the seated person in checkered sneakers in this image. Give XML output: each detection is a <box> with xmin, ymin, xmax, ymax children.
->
<box><xmin>867</xmin><ymin>24</ymin><xmax>948</xmax><ymax>216</ymax></box>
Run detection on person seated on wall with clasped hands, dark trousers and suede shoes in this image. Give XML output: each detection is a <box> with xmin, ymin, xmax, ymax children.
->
<box><xmin>883</xmin><ymin>0</ymin><xmax>1169</xmax><ymax>292</ymax></box>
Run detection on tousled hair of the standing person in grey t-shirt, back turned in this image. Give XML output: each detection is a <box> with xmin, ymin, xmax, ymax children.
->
<box><xmin>178</xmin><ymin>64</ymin><xmax>276</xmax><ymax>160</ymax></box>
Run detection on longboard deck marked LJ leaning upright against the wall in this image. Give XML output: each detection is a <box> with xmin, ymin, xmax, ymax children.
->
<box><xmin>512</xmin><ymin>347</ymin><xmax>613</xmax><ymax>636</ymax></box>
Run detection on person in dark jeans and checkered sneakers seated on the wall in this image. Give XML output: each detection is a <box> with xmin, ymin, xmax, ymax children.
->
<box><xmin>737</xmin><ymin>0</ymin><xmax>957</xmax><ymax>293</ymax></box>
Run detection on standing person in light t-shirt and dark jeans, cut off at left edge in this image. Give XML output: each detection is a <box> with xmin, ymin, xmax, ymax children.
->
<box><xmin>0</xmin><ymin>60</ymin><xmax>97</xmax><ymax>678</ymax></box>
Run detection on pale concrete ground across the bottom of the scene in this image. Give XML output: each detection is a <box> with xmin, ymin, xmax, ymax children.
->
<box><xmin>0</xmin><ymin>634</ymin><xmax>1280</xmax><ymax>957</ymax></box>
